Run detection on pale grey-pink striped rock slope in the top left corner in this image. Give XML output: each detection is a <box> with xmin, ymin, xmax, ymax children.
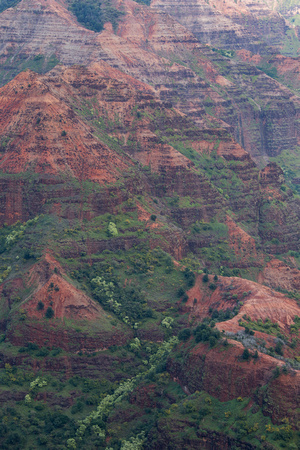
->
<box><xmin>0</xmin><ymin>0</ymin><xmax>112</xmax><ymax>64</ymax></box>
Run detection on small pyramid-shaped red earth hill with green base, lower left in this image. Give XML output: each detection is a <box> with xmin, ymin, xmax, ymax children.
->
<box><xmin>7</xmin><ymin>254</ymin><xmax>131</xmax><ymax>352</ymax></box>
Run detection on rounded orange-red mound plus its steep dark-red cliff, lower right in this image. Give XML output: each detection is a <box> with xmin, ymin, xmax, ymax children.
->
<box><xmin>171</xmin><ymin>270</ymin><xmax>300</xmax><ymax>427</ymax></box>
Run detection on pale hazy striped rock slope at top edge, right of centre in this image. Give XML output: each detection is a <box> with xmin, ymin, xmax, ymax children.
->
<box><xmin>151</xmin><ymin>0</ymin><xmax>286</xmax><ymax>51</ymax></box>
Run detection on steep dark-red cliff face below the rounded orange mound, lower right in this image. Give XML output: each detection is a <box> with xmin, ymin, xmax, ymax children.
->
<box><xmin>170</xmin><ymin>340</ymin><xmax>300</xmax><ymax>426</ymax></box>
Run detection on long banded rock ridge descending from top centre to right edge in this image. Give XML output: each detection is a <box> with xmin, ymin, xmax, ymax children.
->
<box><xmin>113</xmin><ymin>1</ymin><xmax>300</xmax><ymax>163</ymax></box>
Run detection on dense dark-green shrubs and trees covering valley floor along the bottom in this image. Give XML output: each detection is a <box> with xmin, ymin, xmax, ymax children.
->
<box><xmin>0</xmin><ymin>325</ymin><xmax>298</xmax><ymax>449</ymax></box>
